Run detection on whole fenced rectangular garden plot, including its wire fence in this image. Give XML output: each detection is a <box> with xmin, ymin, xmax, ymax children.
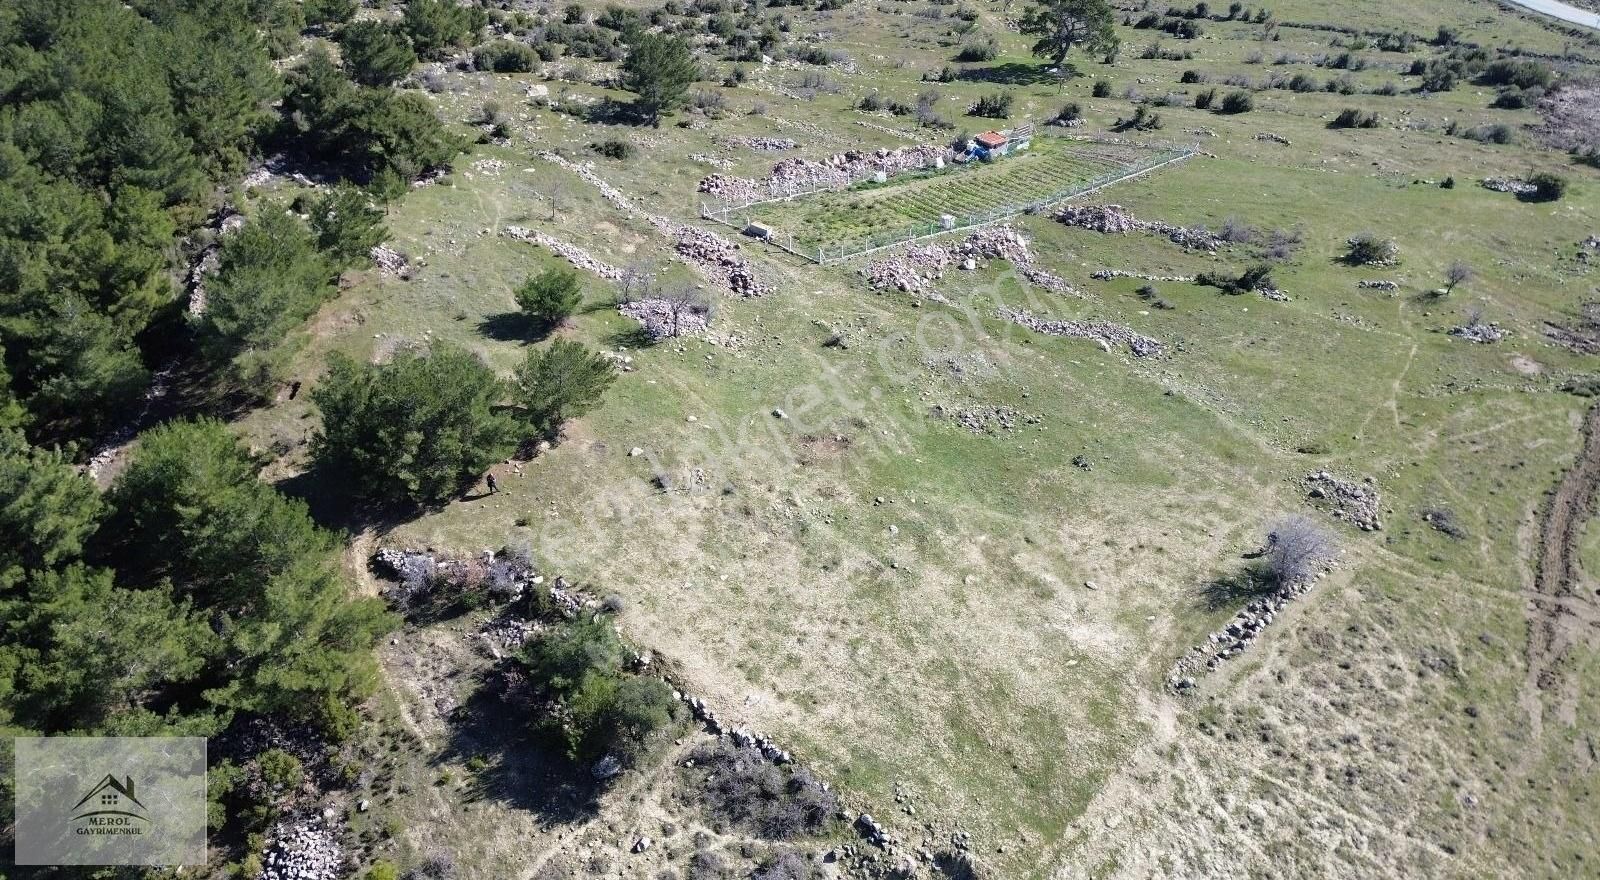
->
<box><xmin>702</xmin><ymin>138</ymin><xmax>1194</xmax><ymax>262</ymax></box>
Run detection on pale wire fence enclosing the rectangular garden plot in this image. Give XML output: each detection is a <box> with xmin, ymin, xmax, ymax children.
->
<box><xmin>701</xmin><ymin>147</ymin><xmax>1200</xmax><ymax>266</ymax></box>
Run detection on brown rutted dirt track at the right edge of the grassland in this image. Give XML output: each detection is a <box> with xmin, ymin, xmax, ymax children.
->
<box><xmin>1518</xmin><ymin>405</ymin><xmax>1600</xmax><ymax>739</ymax></box>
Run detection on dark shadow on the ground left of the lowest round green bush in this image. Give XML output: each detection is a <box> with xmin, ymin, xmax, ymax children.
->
<box><xmin>434</xmin><ymin>664</ymin><xmax>606</xmax><ymax>829</ymax></box>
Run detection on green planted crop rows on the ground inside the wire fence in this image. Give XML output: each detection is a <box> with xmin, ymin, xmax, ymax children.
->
<box><xmin>736</xmin><ymin>136</ymin><xmax>1160</xmax><ymax>256</ymax></box>
